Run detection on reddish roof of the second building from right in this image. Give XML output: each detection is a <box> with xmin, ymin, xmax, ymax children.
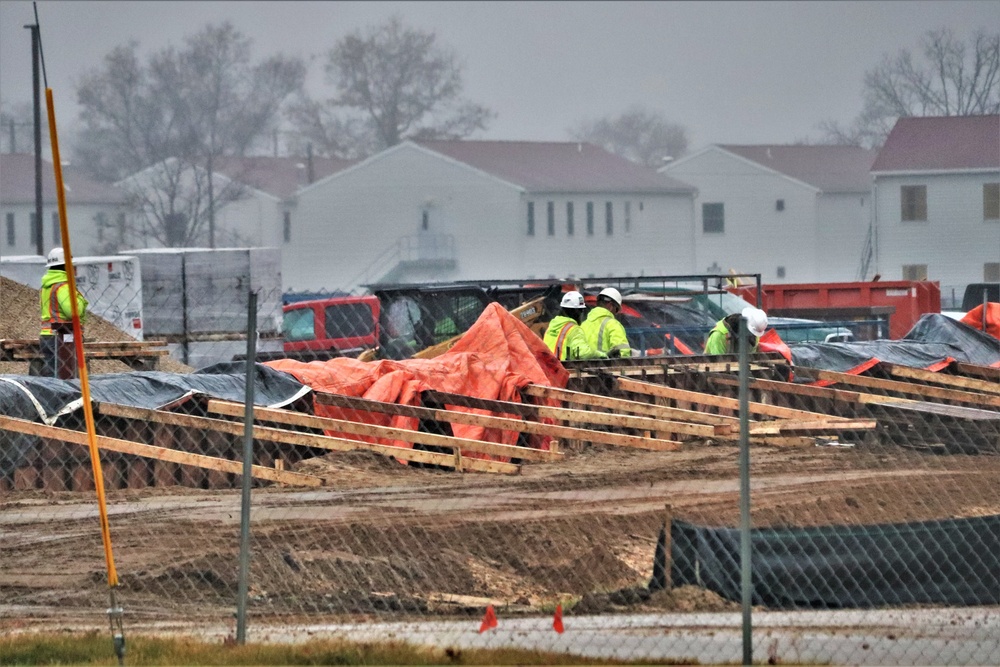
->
<box><xmin>719</xmin><ymin>144</ymin><xmax>876</xmax><ymax>193</ymax></box>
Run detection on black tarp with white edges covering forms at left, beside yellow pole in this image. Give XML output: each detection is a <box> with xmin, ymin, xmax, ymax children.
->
<box><xmin>0</xmin><ymin>362</ymin><xmax>309</xmax><ymax>425</ymax></box>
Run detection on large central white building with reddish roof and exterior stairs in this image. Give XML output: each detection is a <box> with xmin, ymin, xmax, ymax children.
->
<box><xmin>282</xmin><ymin>141</ymin><xmax>695</xmax><ymax>291</ymax></box>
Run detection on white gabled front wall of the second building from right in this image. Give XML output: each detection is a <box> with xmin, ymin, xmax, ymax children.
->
<box><xmin>663</xmin><ymin>150</ymin><xmax>824</xmax><ymax>283</ymax></box>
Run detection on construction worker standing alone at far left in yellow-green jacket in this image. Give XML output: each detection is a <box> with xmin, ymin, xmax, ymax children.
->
<box><xmin>38</xmin><ymin>248</ymin><xmax>89</xmax><ymax>379</ymax></box>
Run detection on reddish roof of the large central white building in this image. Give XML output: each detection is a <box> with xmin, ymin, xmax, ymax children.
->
<box><xmin>414</xmin><ymin>141</ymin><xmax>694</xmax><ymax>194</ymax></box>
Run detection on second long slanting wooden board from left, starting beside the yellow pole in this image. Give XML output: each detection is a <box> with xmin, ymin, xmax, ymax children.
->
<box><xmin>98</xmin><ymin>403</ymin><xmax>521</xmax><ymax>474</ymax></box>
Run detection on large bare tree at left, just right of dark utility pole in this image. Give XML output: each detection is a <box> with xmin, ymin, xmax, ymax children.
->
<box><xmin>76</xmin><ymin>23</ymin><xmax>305</xmax><ymax>246</ymax></box>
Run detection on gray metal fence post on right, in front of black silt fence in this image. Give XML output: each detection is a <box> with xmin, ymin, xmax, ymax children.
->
<box><xmin>738</xmin><ymin>316</ymin><xmax>760</xmax><ymax>665</ymax></box>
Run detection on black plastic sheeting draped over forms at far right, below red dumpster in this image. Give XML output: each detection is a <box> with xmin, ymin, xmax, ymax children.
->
<box><xmin>789</xmin><ymin>313</ymin><xmax>1000</xmax><ymax>373</ymax></box>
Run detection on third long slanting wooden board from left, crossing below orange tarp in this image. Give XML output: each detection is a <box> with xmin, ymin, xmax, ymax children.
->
<box><xmin>208</xmin><ymin>399</ymin><xmax>563</xmax><ymax>461</ymax></box>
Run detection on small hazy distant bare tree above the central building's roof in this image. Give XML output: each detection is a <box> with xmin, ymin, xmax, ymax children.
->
<box><xmin>569</xmin><ymin>106</ymin><xmax>688</xmax><ymax>168</ymax></box>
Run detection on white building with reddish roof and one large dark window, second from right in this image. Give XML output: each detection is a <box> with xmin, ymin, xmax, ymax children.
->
<box><xmin>659</xmin><ymin>145</ymin><xmax>875</xmax><ymax>283</ymax></box>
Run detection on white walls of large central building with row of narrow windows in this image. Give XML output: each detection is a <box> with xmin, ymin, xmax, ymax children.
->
<box><xmin>281</xmin><ymin>146</ymin><xmax>692</xmax><ymax>291</ymax></box>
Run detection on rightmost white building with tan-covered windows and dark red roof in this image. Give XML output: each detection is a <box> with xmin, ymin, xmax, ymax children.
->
<box><xmin>872</xmin><ymin>115</ymin><xmax>1000</xmax><ymax>297</ymax></box>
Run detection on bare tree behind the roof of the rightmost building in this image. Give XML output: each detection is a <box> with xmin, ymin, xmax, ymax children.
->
<box><xmin>819</xmin><ymin>28</ymin><xmax>1000</xmax><ymax>147</ymax></box>
